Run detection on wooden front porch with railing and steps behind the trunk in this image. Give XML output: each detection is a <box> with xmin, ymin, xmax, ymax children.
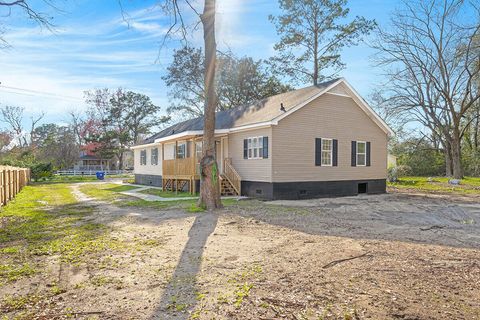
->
<box><xmin>162</xmin><ymin>136</ymin><xmax>241</xmax><ymax>196</ymax></box>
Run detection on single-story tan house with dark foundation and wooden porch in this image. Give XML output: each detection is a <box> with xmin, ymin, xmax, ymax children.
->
<box><xmin>133</xmin><ymin>78</ymin><xmax>393</xmax><ymax>199</ymax></box>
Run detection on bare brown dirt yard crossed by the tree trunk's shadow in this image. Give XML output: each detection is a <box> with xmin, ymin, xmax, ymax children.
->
<box><xmin>0</xmin><ymin>185</ymin><xmax>480</xmax><ymax>320</ymax></box>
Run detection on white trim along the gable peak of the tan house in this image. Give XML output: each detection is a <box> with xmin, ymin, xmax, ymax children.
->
<box><xmin>272</xmin><ymin>78</ymin><xmax>395</xmax><ymax>136</ymax></box>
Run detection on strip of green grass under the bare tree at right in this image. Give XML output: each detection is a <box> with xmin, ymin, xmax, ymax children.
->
<box><xmin>388</xmin><ymin>177</ymin><xmax>480</xmax><ymax>195</ymax></box>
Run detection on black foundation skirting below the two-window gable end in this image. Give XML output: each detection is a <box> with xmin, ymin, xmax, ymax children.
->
<box><xmin>242</xmin><ymin>179</ymin><xmax>387</xmax><ymax>200</ymax></box>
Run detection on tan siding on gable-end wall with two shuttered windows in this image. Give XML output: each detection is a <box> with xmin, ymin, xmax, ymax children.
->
<box><xmin>271</xmin><ymin>94</ymin><xmax>387</xmax><ymax>182</ymax></box>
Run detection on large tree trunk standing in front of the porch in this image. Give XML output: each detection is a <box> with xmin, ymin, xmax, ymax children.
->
<box><xmin>199</xmin><ymin>0</ymin><xmax>222</xmax><ymax>210</ymax></box>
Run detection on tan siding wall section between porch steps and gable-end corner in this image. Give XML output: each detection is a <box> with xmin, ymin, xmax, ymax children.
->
<box><xmin>228</xmin><ymin>128</ymin><xmax>273</xmax><ymax>182</ymax></box>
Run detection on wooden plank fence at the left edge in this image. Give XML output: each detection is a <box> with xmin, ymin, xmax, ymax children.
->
<box><xmin>0</xmin><ymin>166</ymin><xmax>30</xmax><ymax>206</ymax></box>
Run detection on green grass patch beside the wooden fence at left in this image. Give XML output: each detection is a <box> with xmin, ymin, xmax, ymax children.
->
<box><xmin>0</xmin><ymin>184</ymin><xmax>125</xmax><ymax>286</ymax></box>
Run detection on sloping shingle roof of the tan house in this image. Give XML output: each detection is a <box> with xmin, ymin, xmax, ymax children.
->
<box><xmin>140</xmin><ymin>79</ymin><xmax>339</xmax><ymax>145</ymax></box>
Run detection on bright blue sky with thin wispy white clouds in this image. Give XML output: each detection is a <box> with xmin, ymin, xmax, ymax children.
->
<box><xmin>0</xmin><ymin>0</ymin><xmax>397</xmax><ymax>127</ymax></box>
